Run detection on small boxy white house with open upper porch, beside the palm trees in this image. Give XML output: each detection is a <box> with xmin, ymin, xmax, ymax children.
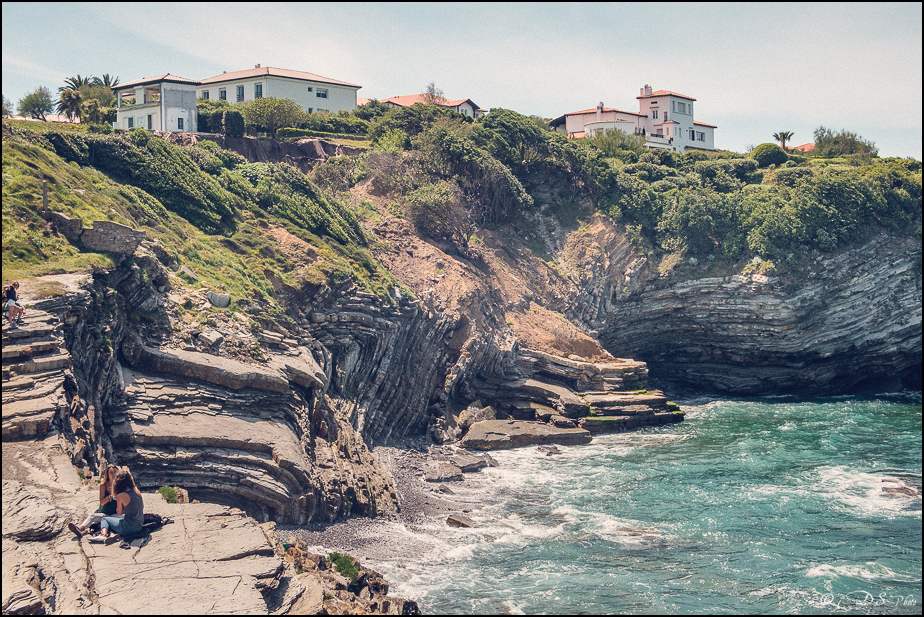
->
<box><xmin>113</xmin><ymin>73</ymin><xmax>199</xmax><ymax>133</ymax></box>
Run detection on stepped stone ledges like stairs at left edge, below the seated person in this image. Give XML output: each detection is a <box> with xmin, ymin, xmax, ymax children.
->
<box><xmin>2</xmin><ymin>309</ymin><xmax>71</xmax><ymax>442</ymax></box>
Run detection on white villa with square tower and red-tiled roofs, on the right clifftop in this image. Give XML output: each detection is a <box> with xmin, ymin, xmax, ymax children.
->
<box><xmin>550</xmin><ymin>84</ymin><xmax>718</xmax><ymax>152</ymax></box>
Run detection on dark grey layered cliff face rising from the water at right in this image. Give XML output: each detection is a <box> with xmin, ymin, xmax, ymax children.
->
<box><xmin>563</xmin><ymin>217</ymin><xmax>921</xmax><ymax>396</ymax></box>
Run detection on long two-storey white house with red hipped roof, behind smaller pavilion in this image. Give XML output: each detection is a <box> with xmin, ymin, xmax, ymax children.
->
<box><xmin>196</xmin><ymin>64</ymin><xmax>361</xmax><ymax>113</ymax></box>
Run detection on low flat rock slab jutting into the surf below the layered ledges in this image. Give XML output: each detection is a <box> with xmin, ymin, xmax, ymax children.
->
<box><xmin>459</xmin><ymin>420</ymin><xmax>591</xmax><ymax>450</ymax></box>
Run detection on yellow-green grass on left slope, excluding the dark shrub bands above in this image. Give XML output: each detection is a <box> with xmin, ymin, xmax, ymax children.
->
<box><xmin>3</xmin><ymin>121</ymin><xmax>394</xmax><ymax>298</ymax></box>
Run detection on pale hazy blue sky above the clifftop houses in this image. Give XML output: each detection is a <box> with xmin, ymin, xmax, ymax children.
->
<box><xmin>2</xmin><ymin>2</ymin><xmax>922</xmax><ymax>160</ymax></box>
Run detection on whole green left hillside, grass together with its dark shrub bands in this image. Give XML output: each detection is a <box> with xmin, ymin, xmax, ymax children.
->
<box><xmin>3</xmin><ymin>121</ymin><xmax>396</xmax><ymax>298</ymax></box>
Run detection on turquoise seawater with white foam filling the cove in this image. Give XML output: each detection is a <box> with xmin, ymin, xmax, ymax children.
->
<box><xmin>369</xmin><ymin>395</ymin><xmax>921</xmax><ymax>614</ymax></box>
